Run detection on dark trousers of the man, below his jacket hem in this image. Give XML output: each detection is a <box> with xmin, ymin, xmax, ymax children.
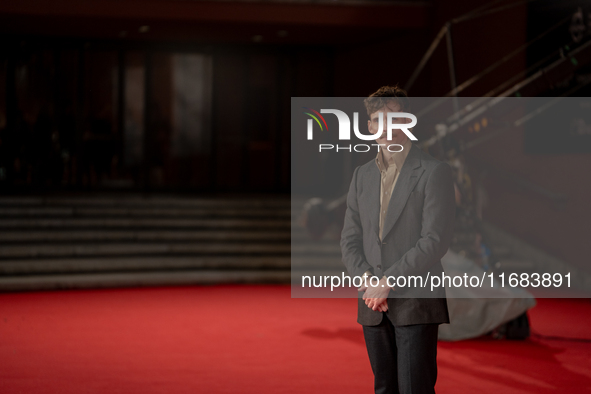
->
<box><xmin>363</xmin><ymin>313</ymin><xmax>439</xmax><ymax>394</ymax></box>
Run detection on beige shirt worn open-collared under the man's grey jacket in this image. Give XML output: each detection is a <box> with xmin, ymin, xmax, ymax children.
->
<box><xmin>375</xmin><ymin>138</ymin><xmax>412</xmax><ymax>240</ymax></box>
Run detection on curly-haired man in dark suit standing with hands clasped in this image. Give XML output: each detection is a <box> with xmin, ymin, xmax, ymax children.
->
<box><xmin>341</xmin><ymin>86</ymin><xmax>455</xmax><ymax>394</ymax></box>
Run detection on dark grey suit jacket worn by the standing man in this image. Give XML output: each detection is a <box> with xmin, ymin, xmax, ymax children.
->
<box><xmin>341</xmin><ymin>144</ymin><xmax>455</xmax><ymax>326</ymax></box>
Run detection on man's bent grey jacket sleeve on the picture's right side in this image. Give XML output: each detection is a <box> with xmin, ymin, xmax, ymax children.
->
<box><xmin>384</xmin><ymin>162</ymin><xmax>456</xmax><ymax>277</ymax></box>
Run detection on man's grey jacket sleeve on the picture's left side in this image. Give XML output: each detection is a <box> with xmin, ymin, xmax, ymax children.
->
<box><xmin>341</xmin><ymin>167</ymin><xmax>371</xmax><ymax>276</ymax></box>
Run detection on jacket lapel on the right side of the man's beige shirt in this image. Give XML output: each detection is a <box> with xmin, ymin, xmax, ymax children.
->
<box><xmin>377</xmin><ymin>144</ymin><xmax>425</xmax><ymax>239</ymax></box>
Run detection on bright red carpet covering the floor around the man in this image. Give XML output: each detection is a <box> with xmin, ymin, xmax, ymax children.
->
<box><xmin>0</xmin><ymin>286</ymin><xmax>591</xmax><ymax>394</ymax></box>
